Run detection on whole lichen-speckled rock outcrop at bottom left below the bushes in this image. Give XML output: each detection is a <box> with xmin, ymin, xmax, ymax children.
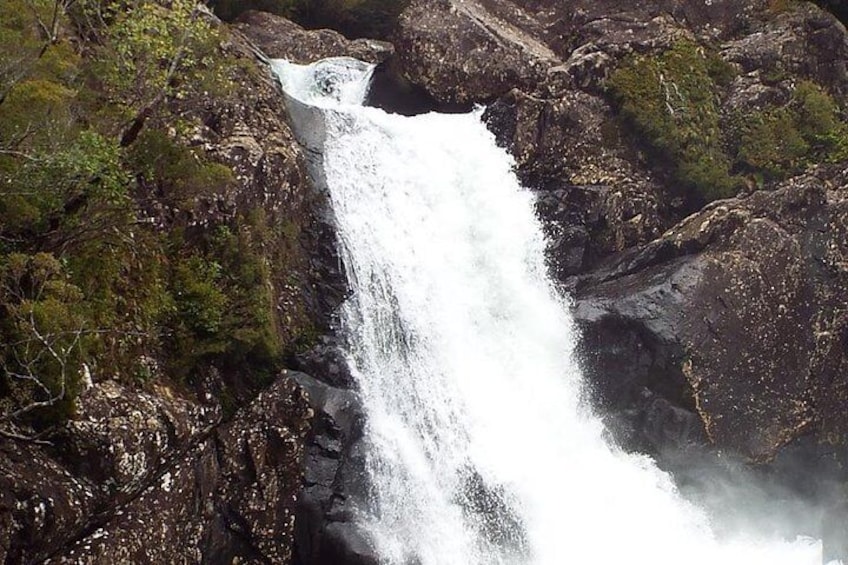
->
<box><xmin>0</xmin><ymin>376</ymin><xmax>311</xmax><ymax>563</ymax></box>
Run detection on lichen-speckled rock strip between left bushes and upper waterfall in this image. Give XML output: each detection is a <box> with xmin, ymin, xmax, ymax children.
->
<box><xmin>151</xmin><ymin>16</ymin><xmax>346</xmax><ymax>352</ymax></box>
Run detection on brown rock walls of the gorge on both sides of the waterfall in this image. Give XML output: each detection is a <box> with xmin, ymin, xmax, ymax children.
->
<box><xmin>0</xmin><ymin>0</ymin><xmax>848</xmax><ymax>565</ymax></box>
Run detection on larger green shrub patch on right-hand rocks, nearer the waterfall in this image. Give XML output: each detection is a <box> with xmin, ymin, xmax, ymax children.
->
<box><xmin>607</xmin><ymin>40</ymin><xmax>740</xmax><ymax>200</ymax></box>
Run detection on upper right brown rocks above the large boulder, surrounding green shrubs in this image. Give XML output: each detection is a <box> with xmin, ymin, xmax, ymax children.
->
<box><xmin>394</xmin><ymin>0</ymin><xmax>846</xmax><ymax>276</ymax></box>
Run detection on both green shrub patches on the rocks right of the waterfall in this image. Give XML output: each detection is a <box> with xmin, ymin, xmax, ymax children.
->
<box><xmin>607</xmin><ymin>40</ymin><xmax>848</xmax><ymax>202</ymax></box>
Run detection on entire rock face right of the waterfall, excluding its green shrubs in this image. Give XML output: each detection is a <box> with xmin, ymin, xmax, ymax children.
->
<box><xmin>394</xmin><ymin>0</ymin><xmax>848</xmax><ymax>472</ymax></box>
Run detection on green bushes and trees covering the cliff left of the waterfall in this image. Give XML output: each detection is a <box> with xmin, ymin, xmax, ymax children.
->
<box><xmin>0</xmin><ymin>0</ymin><xmax>309</xmax><ymax>435</ymax></box>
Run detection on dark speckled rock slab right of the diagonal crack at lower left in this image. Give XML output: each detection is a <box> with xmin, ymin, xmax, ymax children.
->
<box><xmin>48</xmin><ymin>376</ymin><xmax>311</xmax><ymax>564</ymax></box>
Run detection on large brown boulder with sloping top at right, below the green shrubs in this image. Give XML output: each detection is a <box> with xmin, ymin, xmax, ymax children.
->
<box><xmin>576</xmin><ymin>167</ymin><xmax>848</xmax><ymax>461</ymax></box>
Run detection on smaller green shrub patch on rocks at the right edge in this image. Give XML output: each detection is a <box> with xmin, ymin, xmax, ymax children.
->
<box><xmin>736</xmin><ymin>81</ymin><xmax>848</xmax><ymax>180</ymax></box>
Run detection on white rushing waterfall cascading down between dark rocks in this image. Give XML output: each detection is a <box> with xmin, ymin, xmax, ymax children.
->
<box><xmin>275</xmin><ymin>59</ymin><xmax>821</xmax><ymax>565</ymax></box>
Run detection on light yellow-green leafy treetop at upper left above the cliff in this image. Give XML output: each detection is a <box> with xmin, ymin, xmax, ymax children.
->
<box><xmin>73</xmin><ymin>0</ymin><xmax>231</xmax><ymax>146</ymax></box>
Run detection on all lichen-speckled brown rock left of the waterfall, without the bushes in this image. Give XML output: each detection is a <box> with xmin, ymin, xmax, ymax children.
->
<box><xmin>0</xmin><ymin>9</ymin><xmax>346</xmax><ymax>563</ymax></box>
